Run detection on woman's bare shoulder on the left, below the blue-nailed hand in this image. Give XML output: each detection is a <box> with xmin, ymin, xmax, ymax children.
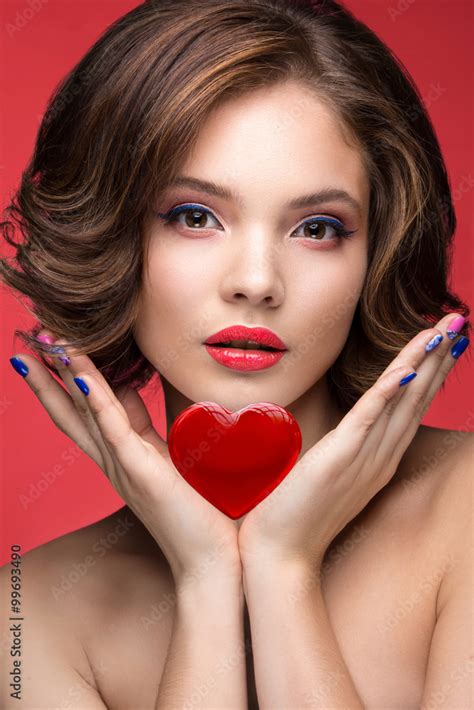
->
<box><xmin>0</xmin><ymin>507</ymin><xmax>171</xmax><ymax>708</ymax></box>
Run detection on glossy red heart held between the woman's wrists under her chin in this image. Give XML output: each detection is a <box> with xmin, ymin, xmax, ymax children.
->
<box><xmin>167</xmin><ymin>402</ymin><xmax>302</xmax><ymax>520</ymax></box>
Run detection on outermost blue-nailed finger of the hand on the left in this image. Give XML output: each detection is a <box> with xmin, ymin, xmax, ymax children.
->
<box><xmin>9</xmin><ymin>353</ymin><xmax>103</xmax><ymax>467</ymax></box>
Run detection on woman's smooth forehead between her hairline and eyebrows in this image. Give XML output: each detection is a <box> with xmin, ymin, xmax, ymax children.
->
<box><xmin>176</xmin><ymin>81</ymin><xmax>368</xmax><ymax>213</ymax></box>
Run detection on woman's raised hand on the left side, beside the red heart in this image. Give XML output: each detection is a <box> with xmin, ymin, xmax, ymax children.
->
<box><xmin>12</xmin><ymin>331</ymin><xmax>241</xmax><ymax>587</ymax></box>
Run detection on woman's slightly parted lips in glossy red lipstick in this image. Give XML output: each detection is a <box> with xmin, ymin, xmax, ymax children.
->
<box><xmin>204</xmin><ymin>325</ymin><xmax>287</xmax><ymax>371</ymax></box>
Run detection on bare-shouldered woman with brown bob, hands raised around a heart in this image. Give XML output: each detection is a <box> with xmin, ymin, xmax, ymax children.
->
<box><xmin>2</xmin><ymin>0</ymin><xmax>472</xmax><ymax>710</ymax></box>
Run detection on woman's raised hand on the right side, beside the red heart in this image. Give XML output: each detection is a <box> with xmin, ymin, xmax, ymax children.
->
<box><xmin>239</xmin><ymin>313</ymin><xmax>469</xmax><ymax>572</ymax></box>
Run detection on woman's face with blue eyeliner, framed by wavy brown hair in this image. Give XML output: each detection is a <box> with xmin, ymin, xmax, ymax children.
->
<box><xmin>134</xmin><ymin>82</ymin><xmax>369</xmax><ymax>418</ymax></box>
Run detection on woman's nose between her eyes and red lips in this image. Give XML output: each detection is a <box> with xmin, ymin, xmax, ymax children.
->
<box><xmin>220</xmin><ymin>232</ymin><xmax>285</xmax><ymax>308</ymax></box>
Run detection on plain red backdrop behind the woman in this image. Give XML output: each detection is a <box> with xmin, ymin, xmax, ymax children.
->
<box><xmin>0</xmin><ymin>0</ymin><xmax>474</xmax><ymax>565</ymax></box>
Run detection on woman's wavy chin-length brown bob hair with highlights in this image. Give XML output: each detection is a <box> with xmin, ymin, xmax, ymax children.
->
<box><xmin>0</xmin><ymin>0</ymin><xmax>469</xmax><ymax>410</ymax></box>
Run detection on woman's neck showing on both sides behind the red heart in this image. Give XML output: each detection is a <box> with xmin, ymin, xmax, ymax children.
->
<box><xmin>161</xmin><ymin>376</ymin><xmax>344</xmax><ymax>458</ymax></box>
